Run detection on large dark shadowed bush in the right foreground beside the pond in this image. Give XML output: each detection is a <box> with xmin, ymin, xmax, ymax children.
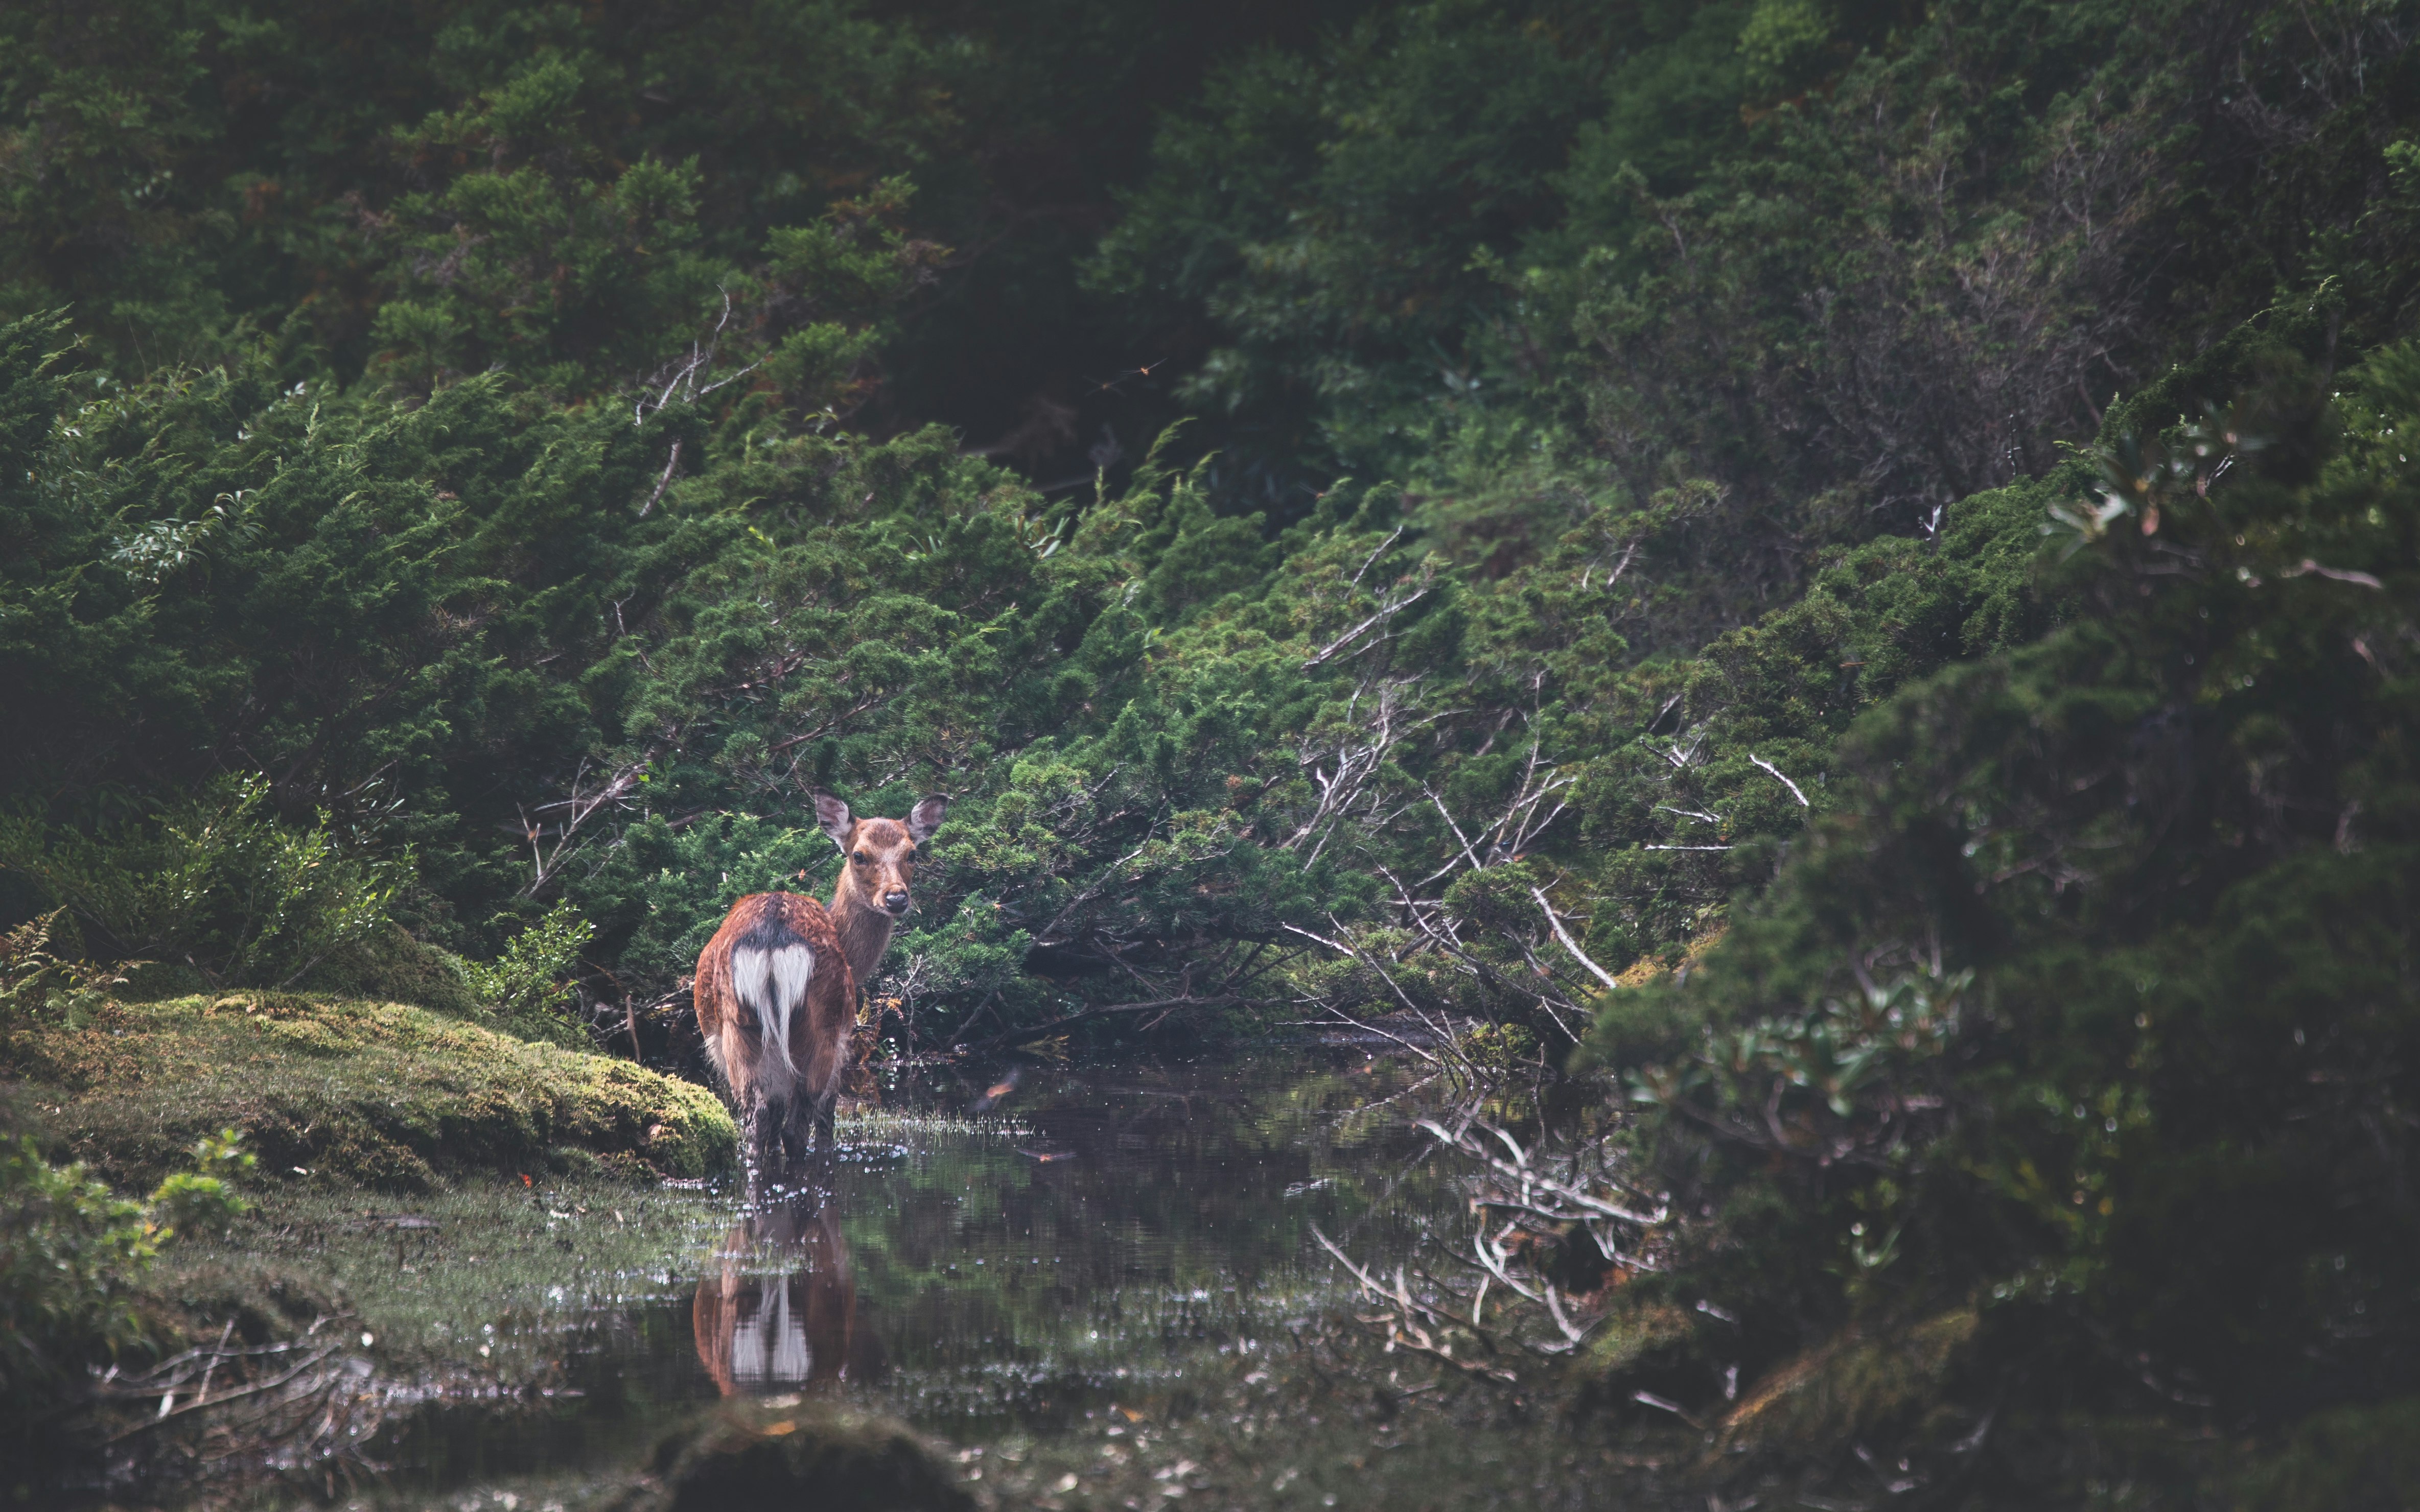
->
<box><xmin>1595</xmin><ymin>344</ymin><xmax>2420</xmax><ymax>1471</ymax></box>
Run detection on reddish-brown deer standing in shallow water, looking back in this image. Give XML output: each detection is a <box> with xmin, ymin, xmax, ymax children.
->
<box><xmin>692</xmin><ymin>791</ymin><xmax>949</xmax><ymax>1193</ymax></box>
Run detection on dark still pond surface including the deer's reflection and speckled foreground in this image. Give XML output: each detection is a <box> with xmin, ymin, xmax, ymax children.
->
<box><xmin>346</xmin><ymin>1050</ymin><xmax>1641</xmax><ymax>1509</ymax></box>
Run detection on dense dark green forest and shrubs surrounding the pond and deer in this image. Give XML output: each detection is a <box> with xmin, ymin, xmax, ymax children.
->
<box><xmin>0</xmin><ymin>0</ymin><xmax>2420</xmax><ymax>1505</ymax></box>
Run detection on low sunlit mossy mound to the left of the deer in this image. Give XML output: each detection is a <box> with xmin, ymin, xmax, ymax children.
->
<box><xmin>0</xmin><ymin>992</ymin><xmax>738</xmax><ymax>1190</ymax></box>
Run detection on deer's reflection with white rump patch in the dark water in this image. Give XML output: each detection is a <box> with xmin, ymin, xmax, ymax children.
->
<box><xmin>692</xmin><ymin>1190</ymin><xmax>883</xmax><ymax>1396</ymax></box>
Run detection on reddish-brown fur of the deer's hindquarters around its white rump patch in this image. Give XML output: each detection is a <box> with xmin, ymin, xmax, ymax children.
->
<box><xmin>694</xmin><ymin>893</ymin><xmax>857</xmax><ymax>1161</ymax></box>
